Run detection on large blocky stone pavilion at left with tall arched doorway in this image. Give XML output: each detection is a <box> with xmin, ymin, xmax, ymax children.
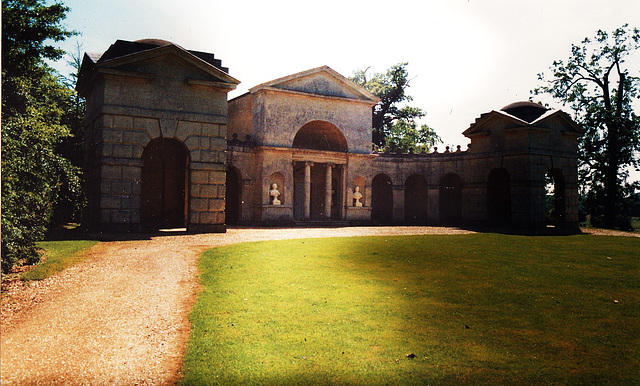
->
<box><xmin>78</xmin><ymin>40</ymin><xmax>239</xmax><ymax>231</ymax></box>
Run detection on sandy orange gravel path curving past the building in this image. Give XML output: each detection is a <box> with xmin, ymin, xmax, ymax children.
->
<box><xmin>0</xmin><ymin>227</ymin><xmax>636</xmax><ymax>385</ymax></box>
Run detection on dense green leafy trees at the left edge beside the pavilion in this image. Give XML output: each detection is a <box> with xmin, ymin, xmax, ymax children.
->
<box><xmin>2</xmin><ymin>0</ymin><xmax>80</xmax><ymax>272</ymax></box>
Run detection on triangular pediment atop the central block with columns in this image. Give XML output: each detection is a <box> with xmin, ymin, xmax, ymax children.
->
<box><xmin>250</xmin><ymin>66</ymin><xmax>379</xmax><ymax>103</ymax></box>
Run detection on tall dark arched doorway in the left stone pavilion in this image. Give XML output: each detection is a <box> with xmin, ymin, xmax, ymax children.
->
<box><xmin>140</xmin><ymin>138</ymin><xmax>189</xmax><ymax>228</ymax></box>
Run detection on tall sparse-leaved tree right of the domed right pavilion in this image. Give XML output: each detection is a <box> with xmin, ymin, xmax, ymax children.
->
<box><xmin>533</xmin><ymin>24</ymin><xmax>640</xmax><ymax>229</ymax></box>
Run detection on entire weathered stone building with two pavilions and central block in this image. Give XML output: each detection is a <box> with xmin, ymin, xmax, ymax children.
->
<box><xmin>79</xmin><ymin>40</ymin><xmax>581</xmax><ymax>231</ymax></box>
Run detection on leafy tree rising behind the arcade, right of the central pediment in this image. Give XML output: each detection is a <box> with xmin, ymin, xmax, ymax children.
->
<box><xmin>350</xmin><ymin>63</ymin><xmax>441</xmax><ymax>151</ymax></box>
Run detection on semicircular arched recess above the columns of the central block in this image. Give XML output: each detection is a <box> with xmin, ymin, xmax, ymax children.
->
<box><xmin>293</xmin><ymin>121</ymin><xmax>348</xmax><ymax>152</ymax></box>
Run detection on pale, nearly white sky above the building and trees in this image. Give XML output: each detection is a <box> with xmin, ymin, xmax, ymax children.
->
<box><xmin>52</xmin><ymin>0</ymin><xmax>640</xmax><ymax>179</ymax></box>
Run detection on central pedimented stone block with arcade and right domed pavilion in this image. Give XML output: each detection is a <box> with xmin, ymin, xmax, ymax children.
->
<box><xmin>227</xmin><ymin>67</ymin><xmax>580</xmax><ymax>231</ymax></box>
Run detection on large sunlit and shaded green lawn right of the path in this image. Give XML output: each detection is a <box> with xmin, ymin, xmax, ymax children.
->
<box><xmin>182</xmin><ymin>234</ymin><xmax>640</xmax><ymax>385</ymax></box>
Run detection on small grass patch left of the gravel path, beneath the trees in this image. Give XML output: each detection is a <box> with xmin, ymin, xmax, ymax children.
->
<box><xmin>21</xmin><ymin>240</ymin><xmax>98</xmax><ymax>280</ymax></box>
